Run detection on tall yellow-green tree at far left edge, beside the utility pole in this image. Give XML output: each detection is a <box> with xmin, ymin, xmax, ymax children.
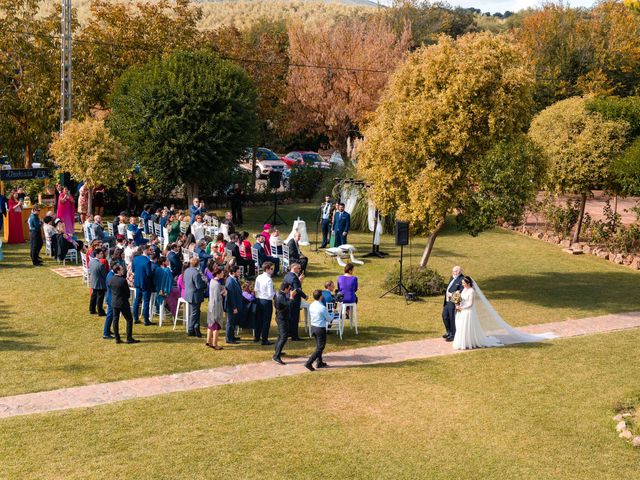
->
<box><xmin>0</xmin><ymin>0</ymin><xmax>60</xmax><ymax>167</ymax></box>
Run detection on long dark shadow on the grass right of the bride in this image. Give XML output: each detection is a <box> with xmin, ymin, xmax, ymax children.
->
<box><xmin>481</xmin><ymin>271</ymin><xmax>640</xmax><ymax>313</ymax></box>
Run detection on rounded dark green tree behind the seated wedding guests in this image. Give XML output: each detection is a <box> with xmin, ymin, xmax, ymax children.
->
<box><xmin>108</xmin><ymin>51</ymin><xmax>257</xmax><ymax>202</ymax></box>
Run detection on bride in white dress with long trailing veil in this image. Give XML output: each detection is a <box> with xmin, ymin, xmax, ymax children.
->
<box><xmin>453</xmin><ymin>277</ymin><xmax>555</xmax><ymax>350</ymax></box>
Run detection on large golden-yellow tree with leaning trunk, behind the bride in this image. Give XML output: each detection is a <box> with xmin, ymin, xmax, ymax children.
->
<box><xmin>358</xmin><ymin>33</ymin><xmax>537</xmax><ymax>266</ymax></box>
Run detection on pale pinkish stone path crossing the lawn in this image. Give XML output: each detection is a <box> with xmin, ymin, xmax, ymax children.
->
<box><xmin>0</xmin><ymin>312</ymin><xmax>640</xmax><ymax>418</ymax></box>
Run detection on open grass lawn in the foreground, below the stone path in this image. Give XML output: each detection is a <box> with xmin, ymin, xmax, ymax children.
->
<box><xmin>0</xmin><ymin>330</ymin><xmax>640</xmax><ymax>480</ymax></box>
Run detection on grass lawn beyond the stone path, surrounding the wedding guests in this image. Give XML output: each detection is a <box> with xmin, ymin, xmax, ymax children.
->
<box><xmin>0</xmin><ymin>205</ymin><xmax>640</xmax><ymax>396</ymax></box>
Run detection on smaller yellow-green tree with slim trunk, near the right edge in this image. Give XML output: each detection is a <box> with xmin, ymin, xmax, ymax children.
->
<box><xmin>529</xmin><ymin>97</ymin><xmax>629</xmax><ymax>242</ymax></box>
